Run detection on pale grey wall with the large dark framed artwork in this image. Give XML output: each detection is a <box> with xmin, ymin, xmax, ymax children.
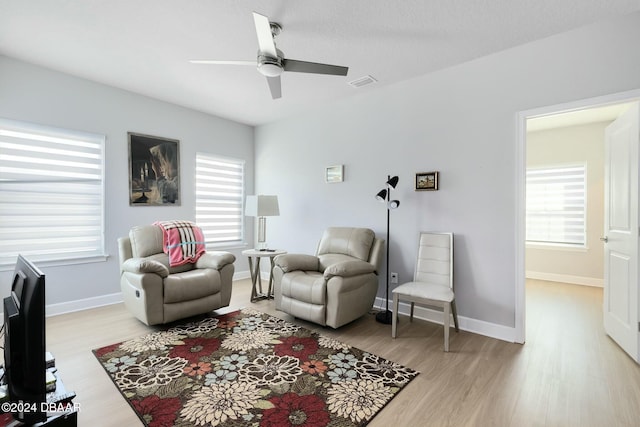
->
<box><xmin>0</xmin><ymin>56</ymin><xmax>254</xmax><ymax>312</ymax></box>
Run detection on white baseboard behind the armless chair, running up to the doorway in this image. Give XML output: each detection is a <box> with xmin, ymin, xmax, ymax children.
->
<box><xmin>374</xmin><ymin>297</ymin><xmax>516</xmax><ymax>342</ymax></box>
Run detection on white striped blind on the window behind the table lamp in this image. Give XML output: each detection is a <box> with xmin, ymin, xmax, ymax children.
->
<box><xmin>196</xmin><ymin>153</ymin><xmax>244</xmax><ymax>246</ymax></box>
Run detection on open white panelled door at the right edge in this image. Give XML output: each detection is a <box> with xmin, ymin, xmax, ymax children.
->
<box><xmin>602</xmin><ymin>104</ymin><xmax>640</xmax><ymax>362</ymax></box>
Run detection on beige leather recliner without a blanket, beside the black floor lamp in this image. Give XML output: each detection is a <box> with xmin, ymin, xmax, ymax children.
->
<box><xmin>273</xmin><ymin>227</ymin><xmax>384</xmax><ymax>328</ymax></box>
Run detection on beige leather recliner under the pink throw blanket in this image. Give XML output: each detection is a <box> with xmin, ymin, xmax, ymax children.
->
<box><xmin>118</xmin><ymin>225</ymin><xmax>236</xmax><ymax>325</ymax></box>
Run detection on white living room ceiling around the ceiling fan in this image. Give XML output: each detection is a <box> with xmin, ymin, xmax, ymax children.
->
<box><xmin>0</xmin><ymin>0</ymin><xmax>640</xmax><ymax>125</ymax></box>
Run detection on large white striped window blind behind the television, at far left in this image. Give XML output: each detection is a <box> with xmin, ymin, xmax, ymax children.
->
<box><xmin>0</xmin><ymin>119</ymin><xmax>105</xmax><ymax>266</ymax></box>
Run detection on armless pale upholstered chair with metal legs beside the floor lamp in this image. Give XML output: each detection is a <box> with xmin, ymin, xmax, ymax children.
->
<box><xmin>391</xmin><ymin>232</ymin><xmax>460</xmax><ymax>351</ymax></box>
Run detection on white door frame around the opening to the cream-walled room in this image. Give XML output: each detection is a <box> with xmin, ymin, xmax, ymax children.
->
<box><xmin>514</xmin><ymin>89</ymin><xmax>640</xmax><ymax>344</ymax></box>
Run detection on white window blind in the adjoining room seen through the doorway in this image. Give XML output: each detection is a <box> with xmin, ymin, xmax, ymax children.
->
<box><xmin>526</xmin><ymin>165</ymin><xmax>586</xmax><ymax>246</ymax></box>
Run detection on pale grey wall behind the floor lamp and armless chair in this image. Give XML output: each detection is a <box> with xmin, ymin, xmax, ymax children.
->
<box><xmin>256</xmin><ymin>14</ymin><xmax>640</xmax><ymax>338</ymax></box>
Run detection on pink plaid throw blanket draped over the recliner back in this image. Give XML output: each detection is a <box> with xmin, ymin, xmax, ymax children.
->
<box><xmin>153</xmin><ymin>221</ymin><xmax>206</xmax><ymax>267</ymax></box>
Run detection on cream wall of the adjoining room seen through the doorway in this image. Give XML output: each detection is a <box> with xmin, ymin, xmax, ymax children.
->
<box><xmin>526</xmin><ymin>122</ymin><xmax>610</xmax><ymax>286</ymax></box>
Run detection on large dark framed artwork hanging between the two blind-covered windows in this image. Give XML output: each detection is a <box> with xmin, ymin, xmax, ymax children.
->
<box><xmin>127</xmin><ymin>132</ymin><xmax>180</xmax><ymax>206</ymax></box>
